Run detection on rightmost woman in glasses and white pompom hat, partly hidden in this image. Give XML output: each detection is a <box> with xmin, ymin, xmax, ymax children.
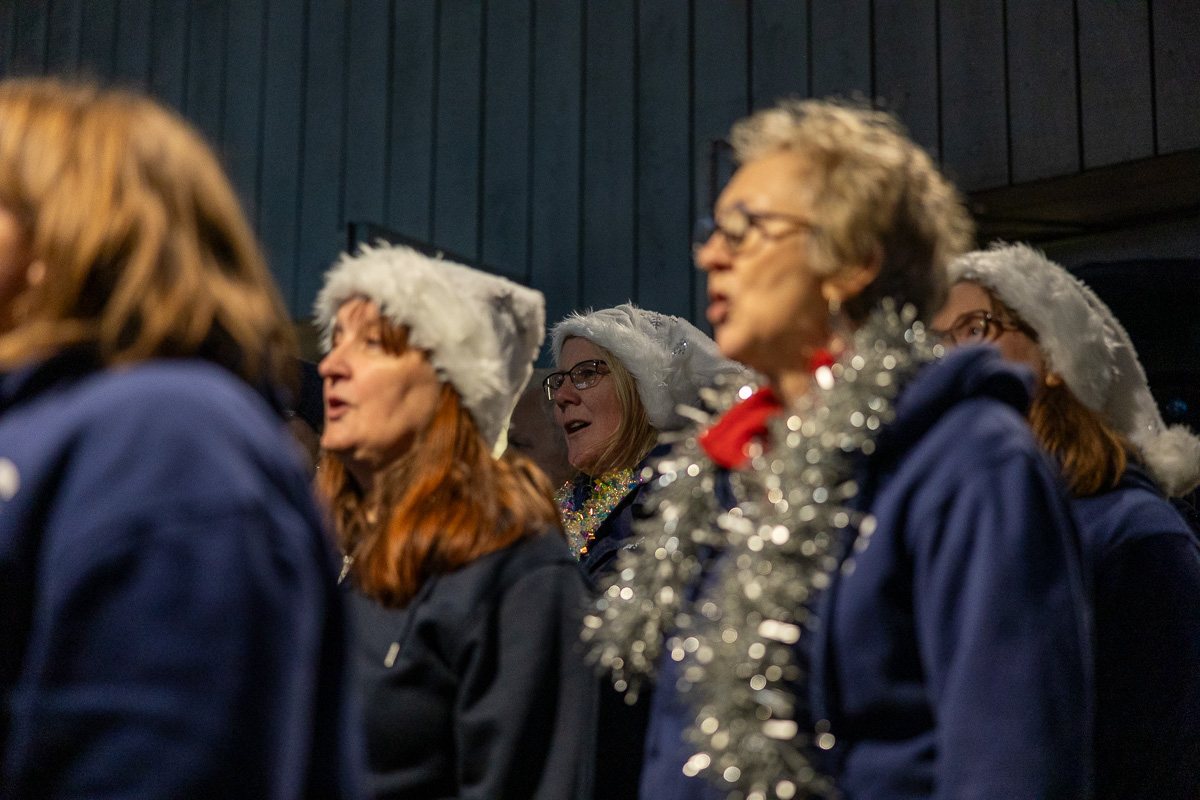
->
<box><xmin>934</xmin><ymin>245</ymin><xmax>1200</xmax><ymax>800</ymax></box>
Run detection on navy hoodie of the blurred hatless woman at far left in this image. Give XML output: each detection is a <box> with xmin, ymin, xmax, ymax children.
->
<box><xmin>0</xmin><ymin>354</ymin><xmax>362</xmax><ymax>800</ymax></box>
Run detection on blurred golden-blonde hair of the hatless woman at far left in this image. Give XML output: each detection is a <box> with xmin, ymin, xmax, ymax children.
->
<box><xmin>0</xmin><ymin>79</ymin><xmax>295</xmax><ymax>381</ymax></box>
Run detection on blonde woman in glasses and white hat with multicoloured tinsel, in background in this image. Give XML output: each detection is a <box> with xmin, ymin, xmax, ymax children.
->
<box><xmin>542</xmin><ymin>303</ymin><xmax>743</xmax><ymax>579</ymax></box>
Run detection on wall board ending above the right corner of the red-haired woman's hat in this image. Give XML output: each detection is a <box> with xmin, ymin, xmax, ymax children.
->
<box><xmin>479</xmin><ymin>0</ymin><xmax>533</xmax><ymax>279</ymax></box>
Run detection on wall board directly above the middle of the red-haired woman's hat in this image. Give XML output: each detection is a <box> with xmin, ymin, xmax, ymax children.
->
<box><xmin>386</xmin><ymin>2</ymin><xmax>437</xmax><ymax>240</ymax></box>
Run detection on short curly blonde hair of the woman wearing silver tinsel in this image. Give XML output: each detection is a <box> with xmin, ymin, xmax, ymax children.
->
<box><xmin>731</xmin><ymin>100</ymin><xmax>974</xmax><ymax>320</ymax></box>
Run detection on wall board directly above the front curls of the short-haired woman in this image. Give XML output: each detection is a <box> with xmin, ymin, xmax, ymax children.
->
<box><xmin>750</xmin><ymin>0</ymin><xmax>811</xmax><ymax>108</ymax></box>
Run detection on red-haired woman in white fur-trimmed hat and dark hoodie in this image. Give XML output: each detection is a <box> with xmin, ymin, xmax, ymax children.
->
<box><xmin>316</xmin><ymin>247</ymin><xmax>595</xmax><ymax>800</ymax></box>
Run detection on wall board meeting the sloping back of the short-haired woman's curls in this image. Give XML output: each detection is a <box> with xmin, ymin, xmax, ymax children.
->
<box><xmin>875</xmin><ymin>0</ymin><xmax>941</xmax><ymax>160</ymax></box>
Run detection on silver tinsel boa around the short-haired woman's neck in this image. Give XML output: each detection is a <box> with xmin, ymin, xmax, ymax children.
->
<box><xmin>583</xmin><ymin>301</ymin><xmax>941</xmax><ymax>800</ymax></box>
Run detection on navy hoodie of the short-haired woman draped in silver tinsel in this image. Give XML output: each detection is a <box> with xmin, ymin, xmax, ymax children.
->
<box><xmin>641</xmin><ymin>348</ymin><xmax>1092</xmax><ymax>800</ymax></box>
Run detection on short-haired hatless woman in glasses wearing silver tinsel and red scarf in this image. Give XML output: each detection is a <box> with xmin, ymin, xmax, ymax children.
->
<box><xmin>584</xmin><ymin>101</ymin><xmax>1091</xmax><ymax>800</ymax></box>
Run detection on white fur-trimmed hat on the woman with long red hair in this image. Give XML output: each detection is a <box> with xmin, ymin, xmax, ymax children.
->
<box><xmin>313</xmin><ymin>245</ymin><xmax>546</xmax><ymax>447</ymax></box>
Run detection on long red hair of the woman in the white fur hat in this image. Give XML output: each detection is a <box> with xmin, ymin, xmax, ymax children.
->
<box><xmin>317</xmin><ymin>323</ymin><xmax>562</xmax><ymax>607</ymax></box>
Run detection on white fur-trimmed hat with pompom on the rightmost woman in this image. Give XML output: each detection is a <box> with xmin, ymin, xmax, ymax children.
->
<box><xmin>949</xmin><ymin>242</ymin><xmax>1200</xmax><ymax>497</ymax></box>
